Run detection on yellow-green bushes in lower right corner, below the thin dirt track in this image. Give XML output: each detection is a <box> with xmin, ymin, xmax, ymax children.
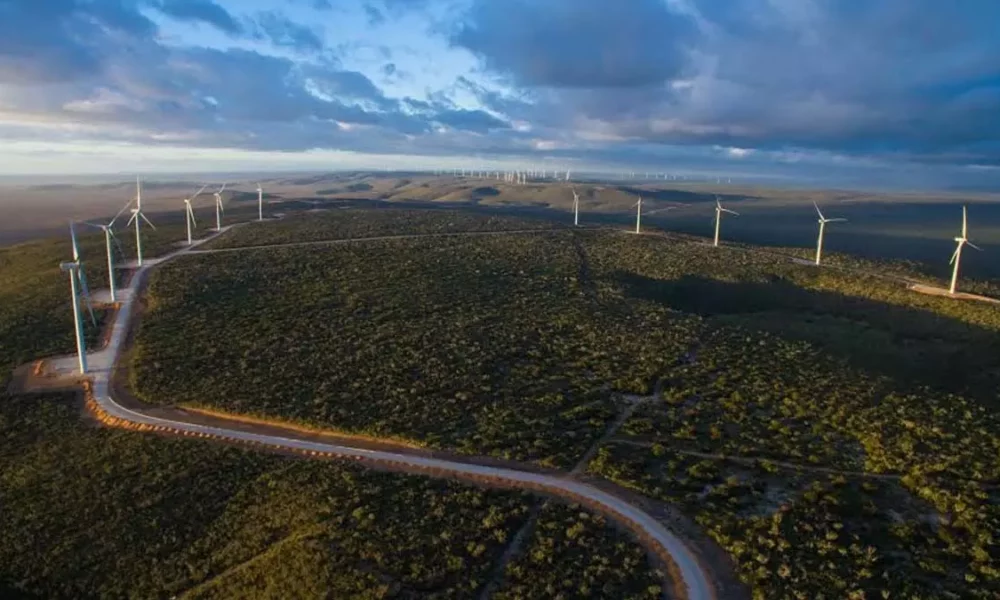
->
<box><xmin>589</xmin><ymin>443</ymin><xmax>1000</xmax><ymax>600</ymax></box>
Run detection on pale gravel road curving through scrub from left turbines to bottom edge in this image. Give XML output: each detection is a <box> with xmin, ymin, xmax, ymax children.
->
<box><xmin>82</xmin><ymin>224</ymin><xmax>715</xmax><ymax>600</ymax></box>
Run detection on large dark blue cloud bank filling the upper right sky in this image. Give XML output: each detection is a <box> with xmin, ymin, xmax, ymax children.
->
<box><xmin>450</xmin><ymin>0</ymin><xmax>1000</xmax><ymax>169</ymax></box>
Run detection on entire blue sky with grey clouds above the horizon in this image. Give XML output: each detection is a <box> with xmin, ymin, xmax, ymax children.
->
<box><xmin>0</xmin><ymin>0</ymin><xmax>1000</xmax><ymax>189</ymax></box>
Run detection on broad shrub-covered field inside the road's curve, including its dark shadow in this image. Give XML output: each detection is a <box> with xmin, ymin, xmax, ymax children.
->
<box><xmin>125</xmin><ymin>211</ymin><xmax>1000</xmax><ymax>598</ymax></box>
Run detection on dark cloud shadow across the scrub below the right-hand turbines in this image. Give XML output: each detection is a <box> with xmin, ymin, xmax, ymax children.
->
<box><xmin>612</xmin><ymin>272</ymin><xmax>1000</xmax><ymax>406</ymax></box>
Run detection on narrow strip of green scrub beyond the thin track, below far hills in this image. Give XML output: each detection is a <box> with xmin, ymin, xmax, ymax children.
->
<box><xmin>205</xmin><ymin>207</ymin><xmax>557</xmax><ymax>248</ymax></box>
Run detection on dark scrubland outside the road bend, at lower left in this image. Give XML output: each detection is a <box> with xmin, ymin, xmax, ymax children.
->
<box><xmin>0</xmin><ymin>225</ymin><xmax>680</xmax><ymax>598</ymax></box>
